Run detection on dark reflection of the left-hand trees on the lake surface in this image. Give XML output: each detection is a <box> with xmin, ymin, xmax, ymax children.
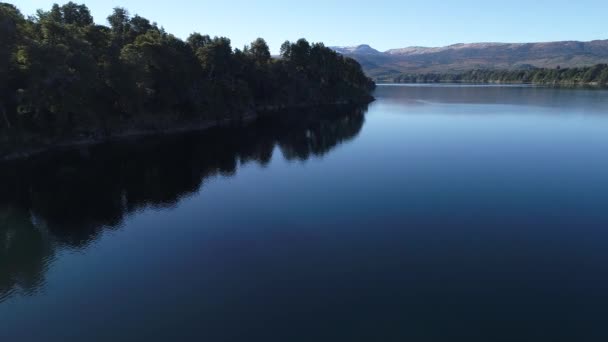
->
<box><xmin>0</xmin><ymin>103</ymin><xmax>367</xmax><ymax>302</ymax></box>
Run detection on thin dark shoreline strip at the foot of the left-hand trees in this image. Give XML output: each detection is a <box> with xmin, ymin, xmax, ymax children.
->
<box><xmin>0</xmin><ymin>96</ymin><xmax>376</xmax><ymax>163</ymax></box>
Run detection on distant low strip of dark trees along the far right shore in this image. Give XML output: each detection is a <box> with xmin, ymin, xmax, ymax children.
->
<box><xmin>392</xmin><ymin>64</ymin><xmax>608</xmax><ymax>86</ymax></box>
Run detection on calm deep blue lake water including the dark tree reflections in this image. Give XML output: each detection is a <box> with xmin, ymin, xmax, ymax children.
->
<box><xmin>0</xmin><ymin>85</ymin><xmax>608</xmax><ymax>342</ymax></box>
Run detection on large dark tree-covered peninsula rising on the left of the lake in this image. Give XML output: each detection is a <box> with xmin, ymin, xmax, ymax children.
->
<box><xmin>0</xmin><ymin>2</ymin><xmax>375</xmax><ymax>158</ymax></box>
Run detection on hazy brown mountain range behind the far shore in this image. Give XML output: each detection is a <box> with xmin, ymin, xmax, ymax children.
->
<box><xmin>332</xmin><ymin>40</ymin><xmax>608</xmax><ymax>80</ymax></box>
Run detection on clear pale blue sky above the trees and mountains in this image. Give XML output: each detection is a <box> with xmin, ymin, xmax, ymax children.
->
<box><xmin>10</xmin><ymin>0</ymin><xmax>608</xmax><ymax>52</ymax></box>
